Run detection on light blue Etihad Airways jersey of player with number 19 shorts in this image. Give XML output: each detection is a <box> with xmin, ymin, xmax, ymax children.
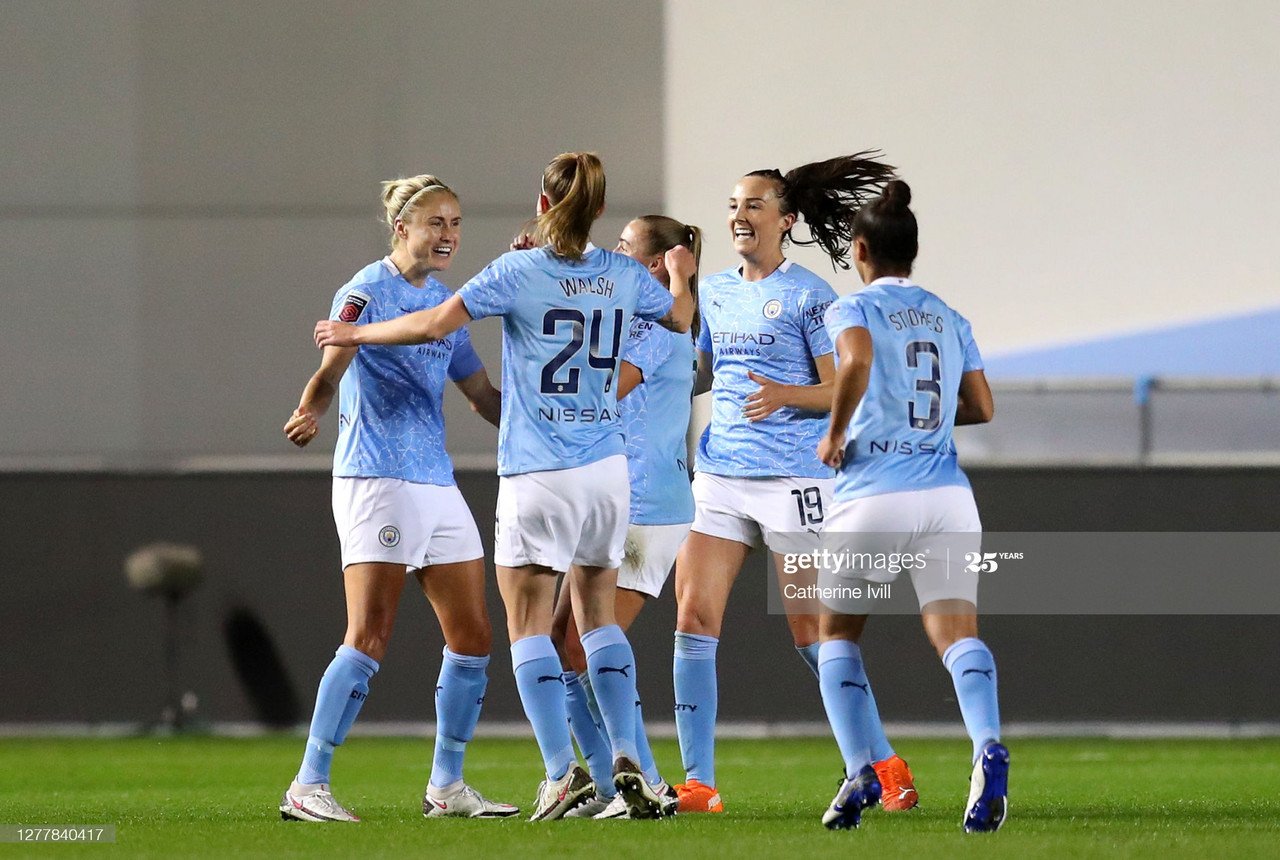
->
<box><xmin>698</xmin><ymin>260</ymin><xmax>836</xmax><ymax>477</ymax></box>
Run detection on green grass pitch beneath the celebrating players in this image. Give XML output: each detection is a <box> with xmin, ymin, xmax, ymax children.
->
<box><xmin>0</xmin><ymin>736</ymin><xmax>1280</xmax><ymax>860</ymax></box>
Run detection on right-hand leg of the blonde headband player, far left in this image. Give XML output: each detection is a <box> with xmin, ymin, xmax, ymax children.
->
<box><xmin>417</xmin><ymin>557</ymin><xmax>520</xmax><ymax>818</ymax></box>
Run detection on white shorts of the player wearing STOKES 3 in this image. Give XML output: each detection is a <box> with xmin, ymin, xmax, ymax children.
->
<box><xmin>823</xmin><ymin>486</ymin><xmax>982</xmax><ymax>609</ymax></box>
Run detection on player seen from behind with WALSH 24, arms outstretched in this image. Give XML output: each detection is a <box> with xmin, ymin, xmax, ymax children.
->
<box><xmin>316</xmin><ymin>152</ymin><xmax>694</xmax><ymax>819</ymax></box>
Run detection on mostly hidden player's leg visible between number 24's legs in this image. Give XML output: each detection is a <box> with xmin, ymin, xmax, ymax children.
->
<box><xmin>552</xmin><ymin>578</ymin><xmax>617</xmax><ymax>818</ymax></box>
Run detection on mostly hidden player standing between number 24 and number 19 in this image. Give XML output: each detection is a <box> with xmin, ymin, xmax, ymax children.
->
<box><xmin>553</xmin><ymin>215</ymin><xmax>703</xmax><ymax>819</ymax></box>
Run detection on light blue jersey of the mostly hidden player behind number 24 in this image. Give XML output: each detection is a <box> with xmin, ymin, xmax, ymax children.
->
<box><xmin>618</xmin><ymin>320</ymin><xmax>694</xmax><ymax>526</ymax></box>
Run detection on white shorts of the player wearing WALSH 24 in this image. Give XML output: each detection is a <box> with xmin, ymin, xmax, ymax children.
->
<box><xmin>493</xmin><ymin>454</ymin><xmax>631</xmax><ymax>573</ymax></box>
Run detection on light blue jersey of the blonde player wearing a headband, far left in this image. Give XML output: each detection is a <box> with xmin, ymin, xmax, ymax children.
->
<box><xmin>329</xmin><ymin>257</ymin><xmax>484</xmax><ymax>486</ymax></box>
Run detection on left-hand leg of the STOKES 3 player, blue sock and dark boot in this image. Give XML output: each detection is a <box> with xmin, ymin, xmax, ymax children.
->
<box><xmin>818</xmin><ymin>612</ymin><xmax>881</xmax><ymax>829</ymax></box>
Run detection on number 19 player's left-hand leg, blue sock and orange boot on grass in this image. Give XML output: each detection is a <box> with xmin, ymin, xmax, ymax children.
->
<box><xmin>673</xmin><ymin>525</ymin><xmax>751</xmax><ymax>813</ymax></box>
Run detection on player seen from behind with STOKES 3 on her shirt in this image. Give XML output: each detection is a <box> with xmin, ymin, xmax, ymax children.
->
<box><xmin>818</xmin><ymin>180</ymin><xmax>1009</xmax><ymax>832</ymax></box>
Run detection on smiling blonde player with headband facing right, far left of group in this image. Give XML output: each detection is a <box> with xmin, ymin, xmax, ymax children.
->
<box><xmin>280</xmin><ymin>174</ymin><xmax>520</xmax><ymax>822</ymax></box>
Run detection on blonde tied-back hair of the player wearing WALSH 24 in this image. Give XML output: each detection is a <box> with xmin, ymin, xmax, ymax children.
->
<box><xmin>536</xmin><ymin>152</ymin><xmax>604</xmax><ymax>260</ymax></box>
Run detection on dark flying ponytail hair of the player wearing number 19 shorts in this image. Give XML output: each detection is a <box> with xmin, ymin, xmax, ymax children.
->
<box><xmin>746</xmin><ymin>150</ymin><xmax>895</xmax><ymax>269</ymax></box>
